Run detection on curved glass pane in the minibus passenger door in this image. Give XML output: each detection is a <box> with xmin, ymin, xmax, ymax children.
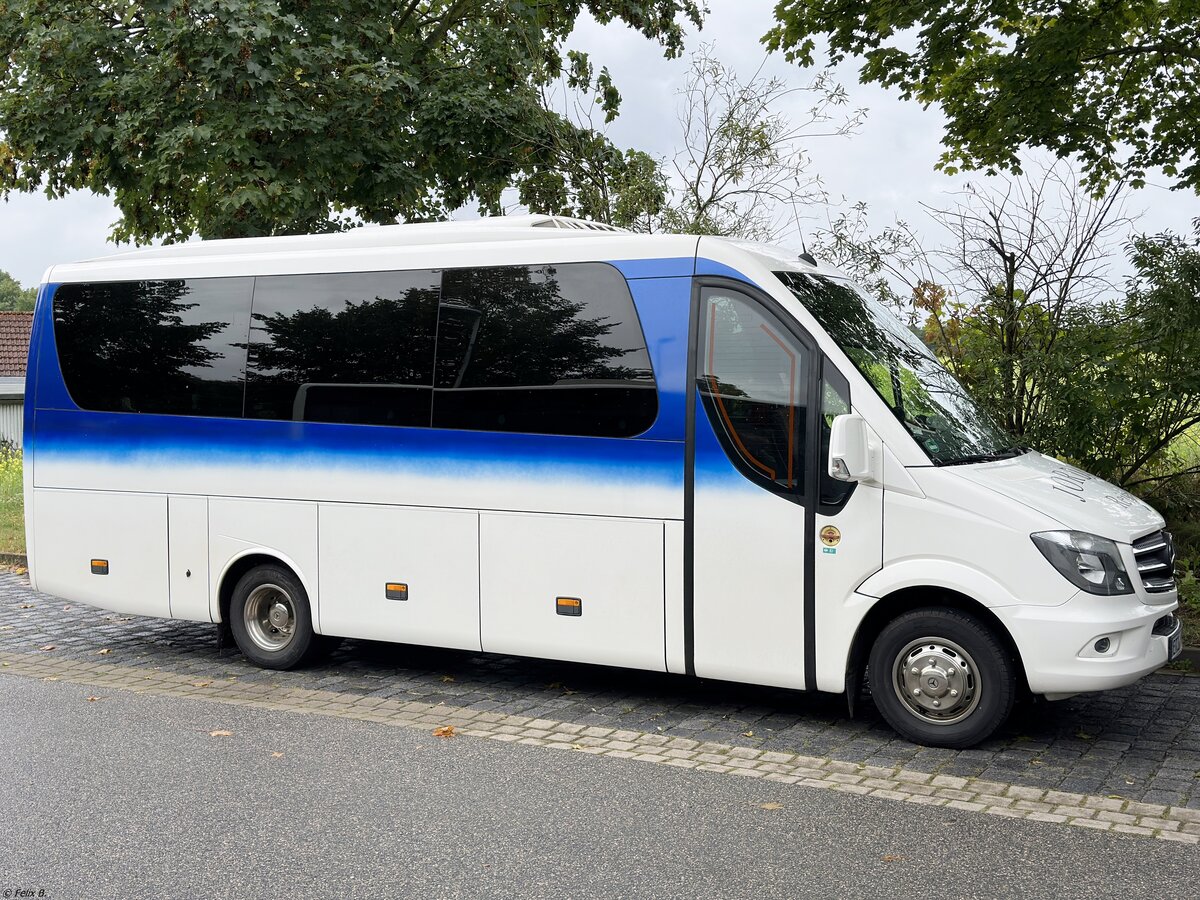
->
<box><xmin>697</xmin><ymin>288</ymin><xmax>810</xmax><ymax>496</ymax></box>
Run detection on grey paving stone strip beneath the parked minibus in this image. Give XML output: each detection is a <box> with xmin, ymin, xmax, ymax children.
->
<box><xmin>7</xmin><ymin>572</ymin><xmax>1200</xmax><ymax>810</ymax></box>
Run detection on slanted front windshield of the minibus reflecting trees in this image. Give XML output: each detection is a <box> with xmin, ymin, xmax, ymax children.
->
<box><xmin>775</xmin><ymin>271</ymin><xmax>1025</xmax><ymax>466</ymax></box>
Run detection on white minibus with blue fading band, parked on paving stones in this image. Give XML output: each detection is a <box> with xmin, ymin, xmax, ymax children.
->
<box><xmin>25</xmin><ymin>216</ymin><xmax>1181</xmax><ymax>748</ymax></box>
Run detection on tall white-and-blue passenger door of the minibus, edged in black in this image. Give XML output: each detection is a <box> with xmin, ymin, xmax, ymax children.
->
<box><xmin>684</xmin><ymin>280</ymin><xmax>820</xmax><ymax>688</ymax></box>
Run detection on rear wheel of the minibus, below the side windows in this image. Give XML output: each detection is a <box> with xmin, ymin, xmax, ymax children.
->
<box><xmin>229</xmin><ymin>565</ymin><xmax>318</xmax><ymax>668</ymax></box>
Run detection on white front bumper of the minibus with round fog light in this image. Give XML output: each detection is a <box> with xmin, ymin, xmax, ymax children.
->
<box><xmin>992</xmin><ymin>592</ymin><xmax>1182</xmax><ymax>700</ymax></box>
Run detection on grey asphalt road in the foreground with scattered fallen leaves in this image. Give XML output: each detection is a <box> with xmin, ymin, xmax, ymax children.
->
<box><xmin>0</xmin><ymin>678</ymin><xmax>1200</xmax><ymax>900</ymax></box>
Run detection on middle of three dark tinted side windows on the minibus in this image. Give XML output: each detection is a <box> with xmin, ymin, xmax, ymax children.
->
<box><xmin>246</xmin><ymin>271</ymin><xmax>438</xmax><ymax>427</ymax></box>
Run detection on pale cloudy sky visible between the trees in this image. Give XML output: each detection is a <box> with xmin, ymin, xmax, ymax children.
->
<box><xmin>0</xmin><ymin>0</ymin><xmax>1200</xmax><ymax>286</ymax></box>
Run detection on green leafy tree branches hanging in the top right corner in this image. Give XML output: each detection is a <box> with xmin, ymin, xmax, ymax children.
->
<box><xmin>764</xmin><ymin>0</ymin><xmax>1200</xmax><ymax>192</ymax></box>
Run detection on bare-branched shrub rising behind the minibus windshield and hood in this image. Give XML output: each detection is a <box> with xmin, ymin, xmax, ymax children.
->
<box><xmin>917</xmin><ymin>164</ymin><xmax>1129</xmax><ymax>444</ymax></box>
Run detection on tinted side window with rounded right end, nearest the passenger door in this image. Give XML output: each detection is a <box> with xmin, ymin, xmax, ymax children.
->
<box><xmin>433</xmin><ymin>263</ymin><xmax>658</xmax><ymax>437</ymax></box>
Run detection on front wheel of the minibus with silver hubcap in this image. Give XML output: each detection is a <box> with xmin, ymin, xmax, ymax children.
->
<box><xmin>869</xmin><ymin>608</ymin><xmax>1018</xmax><ymax>750</ymax></box>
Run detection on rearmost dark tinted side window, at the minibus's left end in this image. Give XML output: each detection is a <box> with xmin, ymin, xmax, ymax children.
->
<box><xmin>54</xmin><ymin>278</ymin><xmax>253</xmax><ymax>416</ymax></box>
